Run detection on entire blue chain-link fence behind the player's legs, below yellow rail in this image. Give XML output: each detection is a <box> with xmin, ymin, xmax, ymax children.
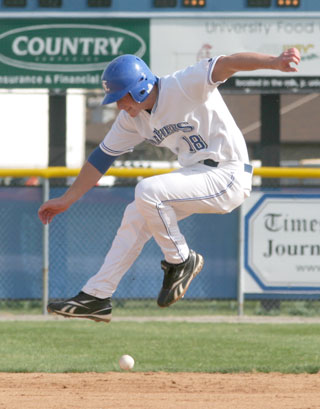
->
<box><xmin>0</xmin><ymin>182</ymin><xmax>238</xmax><ymax>306</ymax></box>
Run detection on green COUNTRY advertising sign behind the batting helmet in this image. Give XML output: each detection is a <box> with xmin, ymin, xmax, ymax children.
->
<box><xmin>0</xmin><ymin>19</ymin><xmax>149</xmax><ymax>88</ymax></box>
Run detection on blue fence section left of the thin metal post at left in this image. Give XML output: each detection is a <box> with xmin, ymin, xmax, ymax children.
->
<box><xmin>0</xmin><ymin>187</ymin><xmax>42</xmax><ymax>299</ymax></box>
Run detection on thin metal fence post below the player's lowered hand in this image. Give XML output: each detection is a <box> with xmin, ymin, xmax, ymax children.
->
<box><xmin>42</xmin><ymin>178</ymin><xmax>50</xmax><ymax>315</ymax></box>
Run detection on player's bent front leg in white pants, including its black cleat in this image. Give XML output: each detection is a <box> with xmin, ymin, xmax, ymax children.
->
<box><xmin>135</xmin><ymin>164</ymin><xmax>244</xmax><ymax>307</ymax></box>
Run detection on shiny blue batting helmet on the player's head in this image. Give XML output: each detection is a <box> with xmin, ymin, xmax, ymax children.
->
<box><xmin>101</xmin><ymin>54</ymin><xmax>157</xmax><ymax>105</ymax></box>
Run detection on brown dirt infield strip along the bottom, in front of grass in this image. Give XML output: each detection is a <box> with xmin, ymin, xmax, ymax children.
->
<box><xmin>0</xmin><ymin>372</ymin><xmax>320</xmax><ymax>409</ymax></box>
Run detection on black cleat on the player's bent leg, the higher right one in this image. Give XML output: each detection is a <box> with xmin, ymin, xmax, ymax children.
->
<box><xmin>157</xmin><ymin>250</ymin><xmax>203</xmax><ymax>307</ymax></box>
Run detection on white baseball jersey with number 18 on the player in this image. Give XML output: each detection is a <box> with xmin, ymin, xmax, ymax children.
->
<box><xmin>100</xmin><ymin>57</ymin><xmax>248</xmax><ymax>166</ymax></box>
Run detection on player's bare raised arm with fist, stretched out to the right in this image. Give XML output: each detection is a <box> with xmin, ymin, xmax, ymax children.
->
<box><xmin>212</xmin><ymin>48</ymin><xmax>300</xmax><ymax>82</ymax></box>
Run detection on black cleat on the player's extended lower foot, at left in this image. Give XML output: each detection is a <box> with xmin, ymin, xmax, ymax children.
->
<box><xmin>47</xmin><ymin>291</ymin><xmax>112</xmax><ymax>322</ymax></box>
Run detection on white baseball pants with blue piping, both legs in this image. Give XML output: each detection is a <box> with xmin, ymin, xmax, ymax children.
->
<box><xmin>82</xmin><ymin>162</ymin><xmax>252</xmax><ymax>298</ymax></box>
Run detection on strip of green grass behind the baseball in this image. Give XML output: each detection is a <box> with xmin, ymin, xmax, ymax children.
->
<box><xmin>0</xmin><ymin>320</ymin><xmax>320</xmax><ymax>373</ymax></box>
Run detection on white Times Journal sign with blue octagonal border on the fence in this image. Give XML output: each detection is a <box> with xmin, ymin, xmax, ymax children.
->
<box><xmin>242</xmin><ymin>192</ymin><xmax>320</xmax><ymax>293</ymax></box>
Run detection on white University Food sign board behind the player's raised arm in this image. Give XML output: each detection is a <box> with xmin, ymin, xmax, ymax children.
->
<box><xmin>150</xmin><ymin>16</ymin><xmax>320</xmax><ymax>89</ymax></box>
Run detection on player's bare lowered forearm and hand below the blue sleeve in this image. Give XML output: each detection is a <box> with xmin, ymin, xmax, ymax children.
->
<box><xmin>38</xmin><ymin>162</ymin><xmax>102</xmax><ymax>224</ymax></box>
